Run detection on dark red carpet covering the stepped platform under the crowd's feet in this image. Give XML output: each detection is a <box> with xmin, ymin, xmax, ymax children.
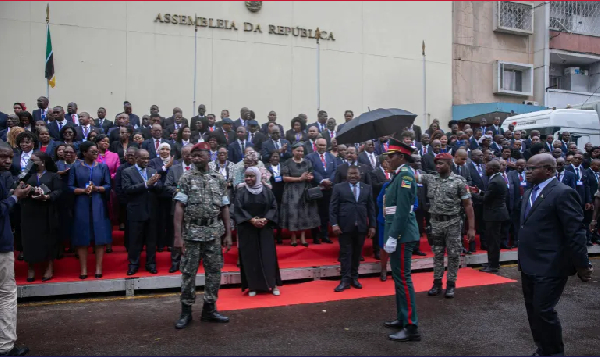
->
<box><xmin>15</xmin><ymin>230</ymin><xmax>516</xmax><ymax>289</ymax></box>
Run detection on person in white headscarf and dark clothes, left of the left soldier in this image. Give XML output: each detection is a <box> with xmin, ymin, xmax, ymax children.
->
<box><xmin>148</xmin><ymin>143</ymin><xmax>177</xmax><ymax>252</ymax></box>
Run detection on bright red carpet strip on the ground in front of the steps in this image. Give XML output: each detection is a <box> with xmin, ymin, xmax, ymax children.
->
<box><xmin>218</xmin><ymin>268</ymin><xmax>516</xmax><ymax>310</ymax></box>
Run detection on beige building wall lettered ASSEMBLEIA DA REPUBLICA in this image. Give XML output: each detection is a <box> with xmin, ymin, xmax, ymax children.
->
<box><xmin>0</xmin><ymin>1</ymin><xmax>452</xmax><ymax>129</ymax></box>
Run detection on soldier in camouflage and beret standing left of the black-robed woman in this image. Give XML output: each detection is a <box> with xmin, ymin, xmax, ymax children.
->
<box><xmin>173</xmin><ymin>143</ymin><xmax>231</xmax><ymax>329</ymax></box>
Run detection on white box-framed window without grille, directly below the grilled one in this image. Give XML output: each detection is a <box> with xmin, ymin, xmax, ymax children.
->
<box><xmin>494</xmin><ymin>61</ymin><xmax>533</xmax><ymax>97</ymax></box>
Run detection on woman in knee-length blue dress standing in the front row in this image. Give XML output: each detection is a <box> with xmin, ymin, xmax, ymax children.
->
<box><xmin>68</xmin><ymin>141</ymin><xmax>112</xmax><ymax>279</ymax></box>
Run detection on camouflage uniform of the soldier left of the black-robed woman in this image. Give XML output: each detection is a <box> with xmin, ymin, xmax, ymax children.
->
<box><xmin>174</xmin><ymin>161</ymin><xmax>229</xmax><ymax>322</ymax></box>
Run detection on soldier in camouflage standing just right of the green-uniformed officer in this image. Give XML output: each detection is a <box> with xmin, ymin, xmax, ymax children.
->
<box><xmin>419</xmin><ymin>153</ymin><xmax>475</xmax><ymax>298</ymax></box>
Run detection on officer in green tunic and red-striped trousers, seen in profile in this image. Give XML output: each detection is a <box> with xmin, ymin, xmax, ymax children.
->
<box><xmin>383</xmin><ymin>139</ymin><xmax>421</xmax><ymax>342</ymax></box>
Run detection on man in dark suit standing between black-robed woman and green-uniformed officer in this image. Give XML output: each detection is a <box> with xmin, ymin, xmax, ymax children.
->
<box><xmin>329</xmin><ymin>166</ymin><xmax>376</xmax><ymax>292</ymax></box>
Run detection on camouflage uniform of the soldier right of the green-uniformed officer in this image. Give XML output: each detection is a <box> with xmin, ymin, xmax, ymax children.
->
<box><xmin>419</xmin><ymin>167</ymin><xmax>471</xmax><ymax>295</ymax></box>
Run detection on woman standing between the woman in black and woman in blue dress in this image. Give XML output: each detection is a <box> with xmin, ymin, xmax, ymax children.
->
<box><xmin>56</xmin><ymin>144</ymin><xmax>79</xmax><ymax>257</ymax></box>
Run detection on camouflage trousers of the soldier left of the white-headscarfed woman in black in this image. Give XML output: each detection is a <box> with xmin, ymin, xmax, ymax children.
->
<box><xmin>181</xmin><ymin>239</ymin><xmax>223</xmax><ymax>305</ymax></box>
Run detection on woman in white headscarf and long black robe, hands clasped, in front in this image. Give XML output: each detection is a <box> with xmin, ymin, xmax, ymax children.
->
<box><xmin>234</xmin><ymin>167</ymin><xmax>281</xmax><ymax>296</ymax></box>
